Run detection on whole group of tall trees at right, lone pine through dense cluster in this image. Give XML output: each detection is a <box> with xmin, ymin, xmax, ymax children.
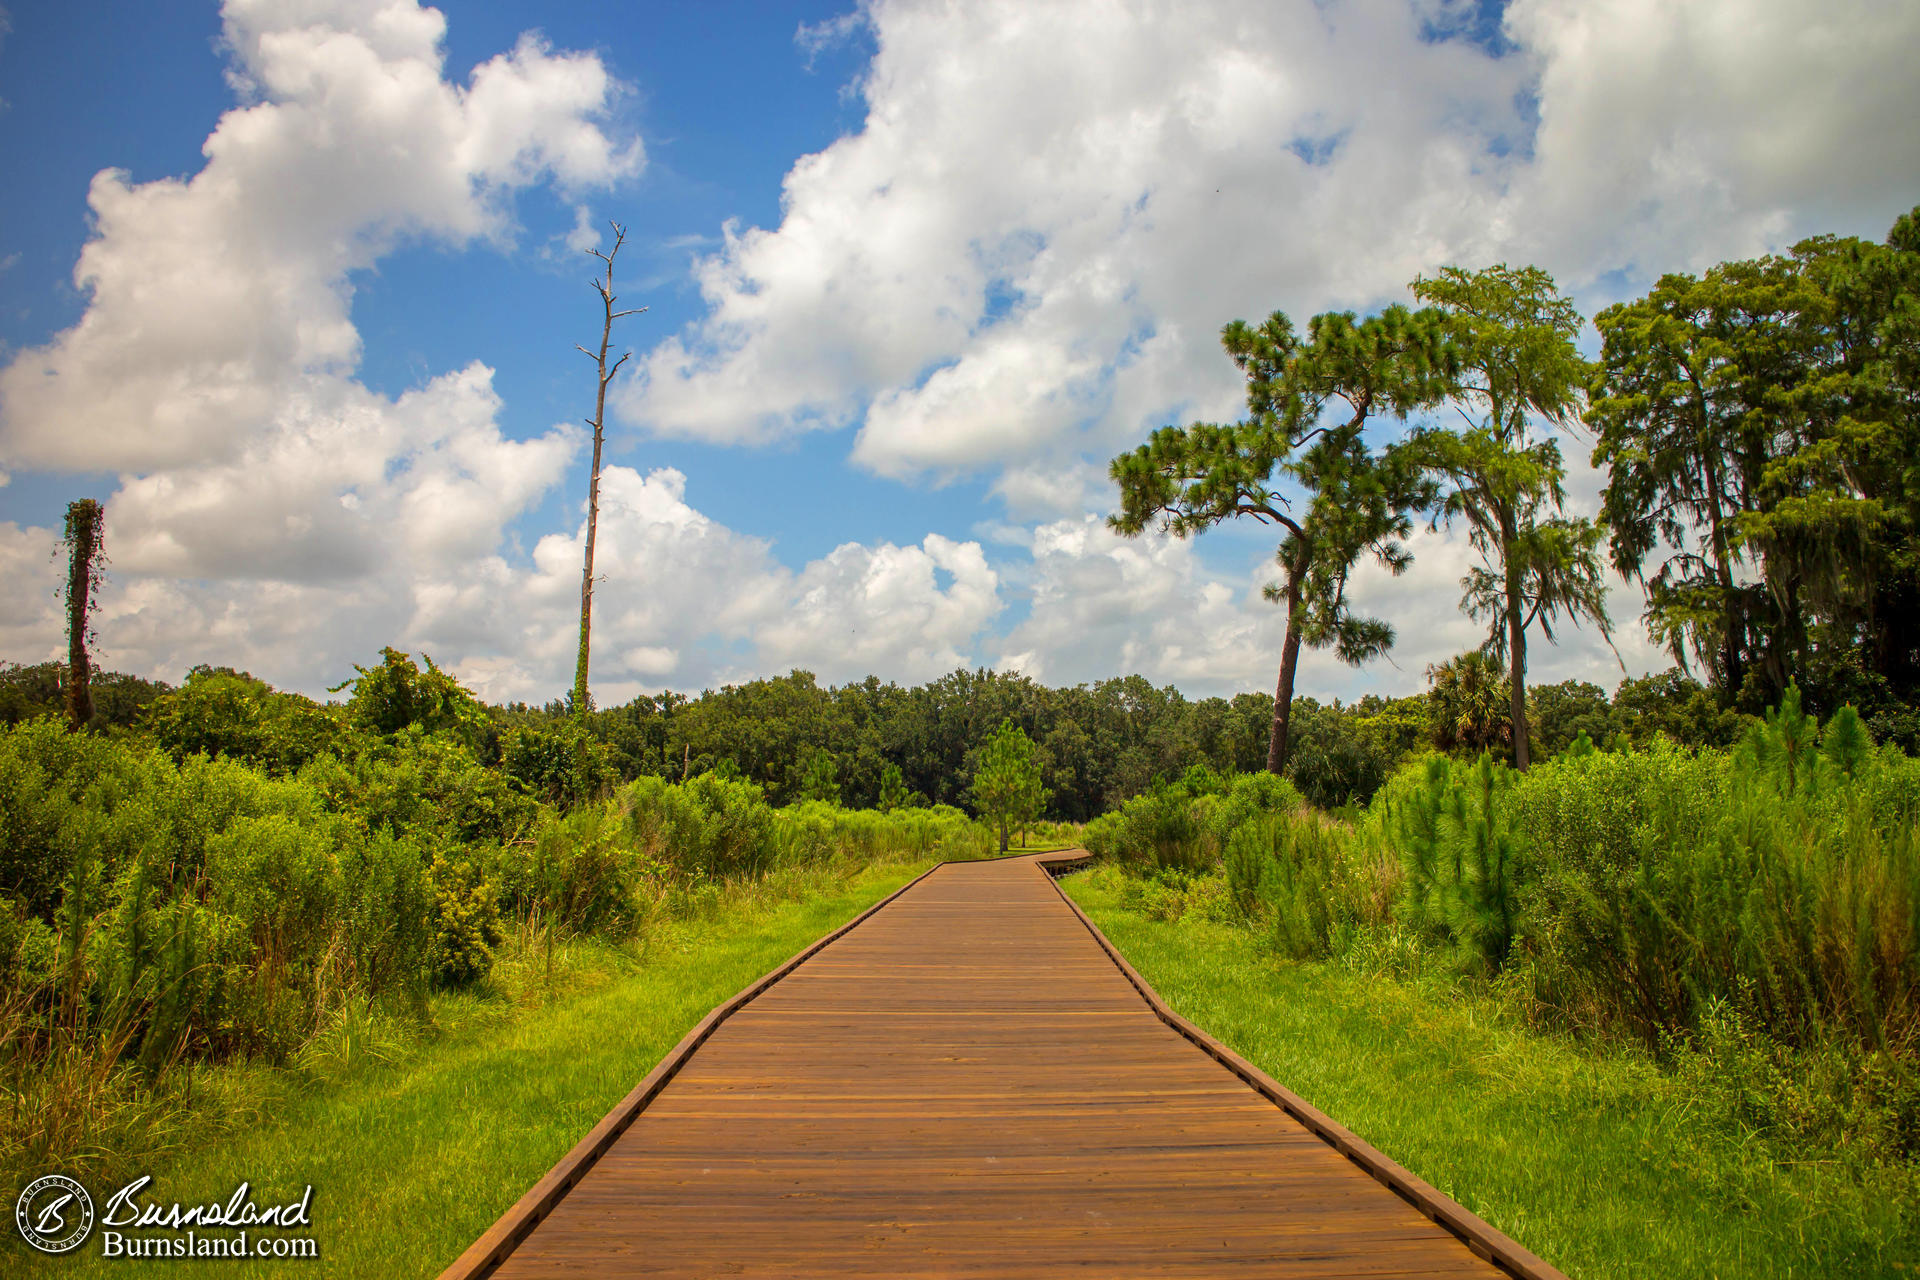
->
<box><xmin>1110</xmin><ymin>209</ymin><xmax>1920</xmax><ymax>773</ymax></box>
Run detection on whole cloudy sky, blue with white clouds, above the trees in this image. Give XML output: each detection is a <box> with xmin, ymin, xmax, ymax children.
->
<box><xmin>0</xmin><ymin>0</ymin><xmax>1920</xmax><ymax>702</ymax></box>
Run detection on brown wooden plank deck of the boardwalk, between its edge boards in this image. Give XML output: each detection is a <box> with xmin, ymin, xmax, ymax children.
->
<box><xmin>447</xmin><ymin>858</ymin><xmax>1557</xmax><ymax>1280</ymax></box>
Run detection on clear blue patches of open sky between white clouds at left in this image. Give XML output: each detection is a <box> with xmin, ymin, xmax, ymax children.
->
<box><xmin>0</xmin><ymin>2</ymin><xmax>985</xmax><ymax>564</ymax></box>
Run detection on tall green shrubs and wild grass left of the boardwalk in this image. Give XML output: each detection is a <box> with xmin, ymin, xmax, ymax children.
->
<box><xmin>0</xmin><ymin>720</ymin><xmax>989</xmax><ymax>1173</ymax></box>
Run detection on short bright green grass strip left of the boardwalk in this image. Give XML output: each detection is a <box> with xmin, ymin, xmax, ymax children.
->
<box><xmin>0</xmin><ymin>860</ymin><xmax>931</xmax><ymax>1278</ymax></box>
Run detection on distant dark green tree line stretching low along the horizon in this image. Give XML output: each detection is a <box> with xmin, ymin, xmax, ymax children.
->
<box><xmin>0</xmin><ymin>649</ymin><xmax>1749</xmax><ymax>821</ymax></box>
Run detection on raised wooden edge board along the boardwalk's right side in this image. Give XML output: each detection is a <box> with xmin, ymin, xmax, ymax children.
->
<box><xmin>1033</xmin><ymin>850</ymin><xmax>1567</xmax><ymax>1280</ymax></box>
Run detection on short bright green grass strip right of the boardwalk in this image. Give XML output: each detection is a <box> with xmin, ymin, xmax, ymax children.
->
<box><xmin>1062</xmin><ymin>869</ymin><xmax>1920</xmax><ymax>1280</ymax></box>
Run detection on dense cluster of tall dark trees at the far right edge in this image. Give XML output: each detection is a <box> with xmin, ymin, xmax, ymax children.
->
<box><xmin>1590</xmin><ymin>215</ymin><xmax>1920</xmax><ymax>729</ymax></box>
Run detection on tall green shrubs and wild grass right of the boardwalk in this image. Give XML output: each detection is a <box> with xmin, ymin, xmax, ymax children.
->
<box><xmin>1089</xmin><ymin>691</ymin><xmax>1920</xmax><ymax>1161</ymax></box>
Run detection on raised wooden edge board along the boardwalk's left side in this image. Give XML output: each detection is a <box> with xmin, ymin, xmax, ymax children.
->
<box><xmin>428</xmin><ymin>862</ymin><xmax>947</xmax><ymax>1280</ymax></box>
